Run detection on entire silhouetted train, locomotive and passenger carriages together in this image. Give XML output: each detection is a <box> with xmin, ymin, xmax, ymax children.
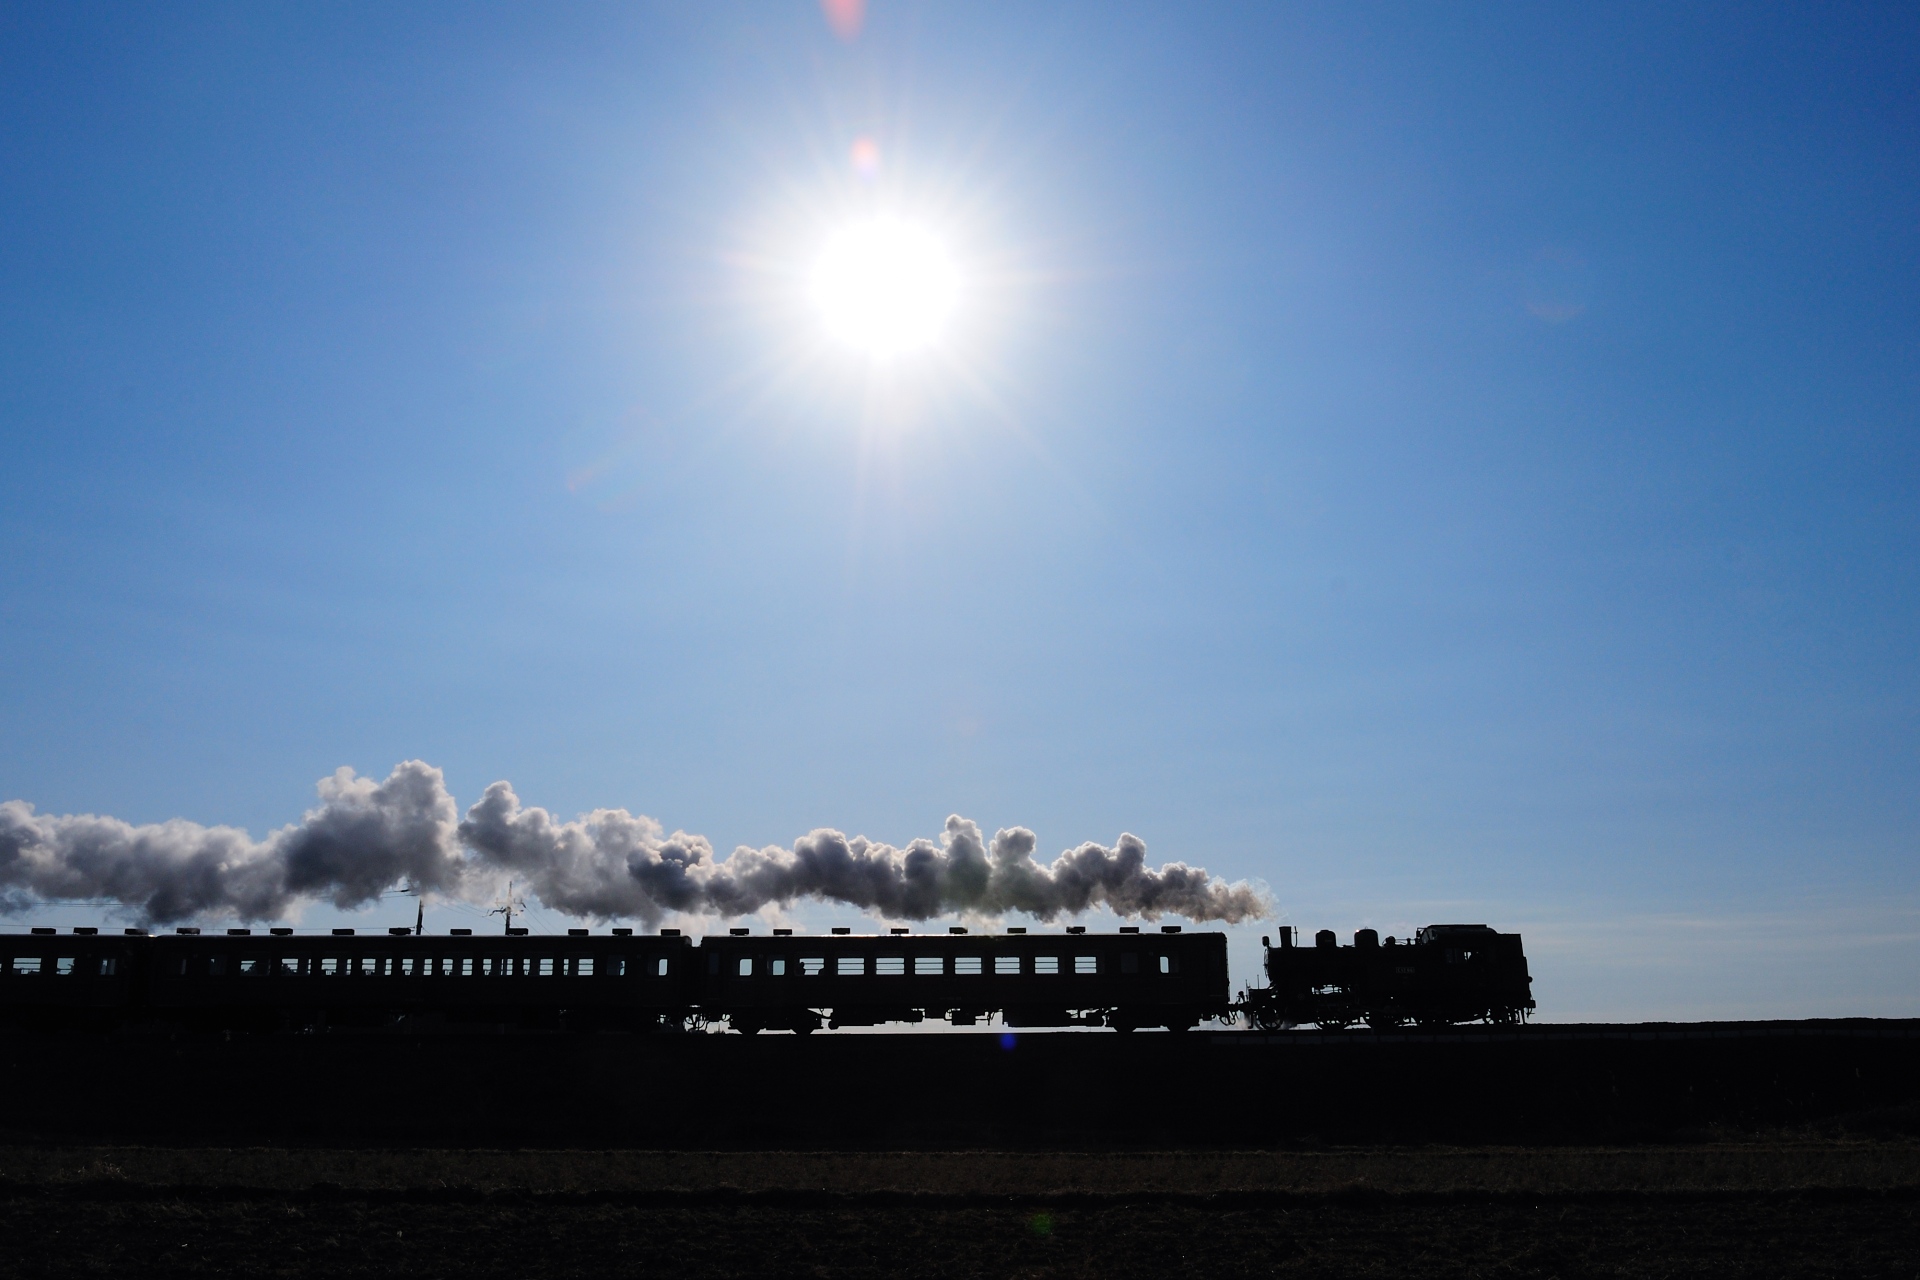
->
<box><xmin>0</xmin><ymin>925</ymin><xmax>1534</xmax><ymax>1034</ymax></box>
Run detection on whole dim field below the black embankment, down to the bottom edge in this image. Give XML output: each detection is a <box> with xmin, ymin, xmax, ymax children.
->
<box><xmin>0</xmin><ymin>1142</ymin><xmax>1920</xmax><ymax>1278</ymax></box>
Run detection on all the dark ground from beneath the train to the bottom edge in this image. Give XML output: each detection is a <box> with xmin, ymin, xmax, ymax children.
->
<box><xmin>0</xmin><ymin>1023</ymin><xmax>1920</xmax><ymax>1278</ymax></box>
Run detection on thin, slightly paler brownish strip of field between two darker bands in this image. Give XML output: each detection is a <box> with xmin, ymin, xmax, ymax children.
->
<box><xmin>0</xmin><ymin>1140</ymin><xmax>1920</xmax><ymax>1197</ymax></box>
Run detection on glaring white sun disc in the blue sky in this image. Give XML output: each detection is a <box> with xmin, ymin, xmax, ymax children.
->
<box><xmin>812</xmin><ymin>217</ymin><xmax>960</xmax><ymax>357</ymax></box>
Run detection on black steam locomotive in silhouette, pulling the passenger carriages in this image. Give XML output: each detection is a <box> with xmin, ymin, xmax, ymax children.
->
<box><xmin>1240</xmin><ymin>925</ymin><xmax>1534</xmax><ymax>1031</ymax></box>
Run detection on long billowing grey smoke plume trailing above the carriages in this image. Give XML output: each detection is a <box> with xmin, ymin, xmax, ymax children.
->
<box><xmin>0</xmin><ymin>760</ymin><xmax>1271</xmax><ymax>925</ymax></box>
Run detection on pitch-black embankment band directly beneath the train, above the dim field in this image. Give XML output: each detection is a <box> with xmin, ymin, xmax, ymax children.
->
<box><xmin>0</xmin><ymin>1019</ymin><xmax>1920</xmax><ymax>1150</ymax></box>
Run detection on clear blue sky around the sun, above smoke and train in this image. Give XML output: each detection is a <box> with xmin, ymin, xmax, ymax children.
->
<box><xmin>0</xmin><ymin>0</ymin><xmax>1920</xmax><ymax>1017</ymax></box>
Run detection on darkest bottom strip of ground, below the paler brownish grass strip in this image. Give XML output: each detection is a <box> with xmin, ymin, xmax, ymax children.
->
<box><xmin>0</xmin><ymin>1194</ymin><xmax>1920</xmax><ymax>1276</ymax></box>
